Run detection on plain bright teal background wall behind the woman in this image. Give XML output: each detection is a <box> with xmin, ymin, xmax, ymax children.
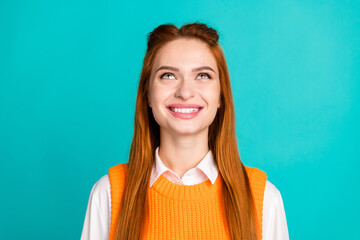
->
<box><xmin>0</xmin><ymin>0</ymin><xmax>360</xmax><ymax>239</ymax></box>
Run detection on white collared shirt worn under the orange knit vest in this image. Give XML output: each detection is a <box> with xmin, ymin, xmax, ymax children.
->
<box><xmin>81</xmin><ymin>147</ymin><xmax>289</xmax><ymax>240</ymax></box>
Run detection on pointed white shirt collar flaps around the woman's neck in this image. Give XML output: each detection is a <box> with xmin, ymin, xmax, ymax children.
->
<box><xmin>150</xmin><ymin>147</ymin><xmax>218</xmax><ymax>187</ymax></box>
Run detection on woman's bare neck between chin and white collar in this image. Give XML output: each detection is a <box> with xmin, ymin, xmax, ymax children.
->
<box><xmin>159</xmin><ymin>129</ymin><xmax>209</xmax><ymax>178</ymax></box>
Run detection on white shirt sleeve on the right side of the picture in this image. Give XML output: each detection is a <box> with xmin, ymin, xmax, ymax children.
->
<box><xmin>263</xmin><ymin>181</ymin><xmax>289</xmax><ymax>240</ymax></box>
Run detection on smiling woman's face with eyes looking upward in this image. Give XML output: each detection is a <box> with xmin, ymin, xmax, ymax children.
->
<box><xmin>148</xmin><ymin>39</ymin><xmax>220</xmax><ymax>135</ymax></box>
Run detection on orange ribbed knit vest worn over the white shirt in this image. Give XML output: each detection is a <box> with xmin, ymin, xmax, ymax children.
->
<box><xmin>109</xmin><ymin>163</ymin><xmax>266</xmax><ymax>240</ymax></box>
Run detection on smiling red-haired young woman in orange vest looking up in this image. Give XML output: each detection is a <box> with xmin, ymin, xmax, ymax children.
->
<box><xmin>81</xmin><ymin>23</ymin><xmax>289</xmax><ymax>240</ymax></box>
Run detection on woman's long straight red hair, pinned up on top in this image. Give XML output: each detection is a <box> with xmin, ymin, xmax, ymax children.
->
<box><xmin>115</xmin><ymin>23</ymin><xmax>257</xmax><ymax>240</ymax></box>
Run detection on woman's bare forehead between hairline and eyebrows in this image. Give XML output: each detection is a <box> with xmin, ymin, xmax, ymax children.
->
<box><xmin>153</xmin><ymin>38</ymin><xmax>217</xmax><ymax>71</ymax></box>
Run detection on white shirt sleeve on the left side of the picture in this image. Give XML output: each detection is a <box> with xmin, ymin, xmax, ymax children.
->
<box><xmin>81</xmin><ymin>174</ymin><xmax>111</xmax><ymax>240</ymax></box>
